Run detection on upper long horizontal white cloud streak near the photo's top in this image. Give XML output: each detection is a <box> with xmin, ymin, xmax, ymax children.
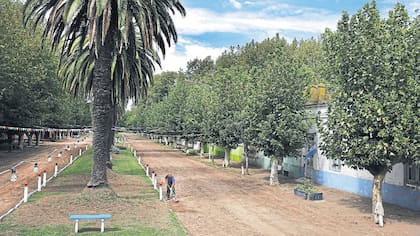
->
<box><xmin>175</xmin><ymin>8</ymin><xmax>340</xmax><ymax>35</ymax></box>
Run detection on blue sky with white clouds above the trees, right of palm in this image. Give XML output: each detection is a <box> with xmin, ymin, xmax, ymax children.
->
<box><xmin>156</xmin><ymin>0</ymin><xmax>420</xmax><ymax>73</ymax></box>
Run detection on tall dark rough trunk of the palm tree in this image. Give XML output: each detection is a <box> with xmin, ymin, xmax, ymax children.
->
<box><xmin>88</xmin><ymin>27</ymin><xmax>115</xmax><ymax>187</ymax></box>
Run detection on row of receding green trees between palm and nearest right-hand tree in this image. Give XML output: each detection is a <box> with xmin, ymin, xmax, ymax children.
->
<box><xmin>123</xmin><ymin>35</ymin><xmax>327</xmax><ymax>181</ymax></box>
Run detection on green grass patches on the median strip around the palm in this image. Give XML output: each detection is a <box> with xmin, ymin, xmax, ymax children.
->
<box><xmin>0</xmin><ymin>147</ymin><xmax>186</xmax><ymax>236</ymax></box>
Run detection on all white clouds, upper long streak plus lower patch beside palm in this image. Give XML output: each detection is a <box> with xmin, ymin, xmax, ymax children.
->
<box><xmin>158</xmin><ymin>0</ymin><xmax>341</xmax><ymax>72</ymax></box>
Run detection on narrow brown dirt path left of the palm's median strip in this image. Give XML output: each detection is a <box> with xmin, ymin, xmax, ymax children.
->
<box><xmin>0</xmin><ymin>137</ymin><xmax>91</xmax><ymax>219</ymax></box>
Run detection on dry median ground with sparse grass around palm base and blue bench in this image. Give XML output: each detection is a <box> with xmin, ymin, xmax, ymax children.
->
<box><xmin>0</xmin><ymin>143</ymin><xmax>185</xmax><ymax>236</ymax></box>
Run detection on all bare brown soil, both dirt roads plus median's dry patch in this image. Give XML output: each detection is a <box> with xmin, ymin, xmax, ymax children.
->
<box><xmin>0</xmin><ymin>134</ymin><xmax>420</xmax><ymax>236</ymax></box>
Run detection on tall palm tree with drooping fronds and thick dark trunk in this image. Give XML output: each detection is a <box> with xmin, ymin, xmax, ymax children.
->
<box><xmin>24</xmin><ymin>0</ymin><xmax>185</xmax><ymax>187</ymax></box>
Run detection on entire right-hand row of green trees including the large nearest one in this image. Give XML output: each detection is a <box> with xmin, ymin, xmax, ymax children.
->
<box><xmin>123</xmin><ymin>1</ymin><xmax>420</xmax><ymax>221</ymax></box>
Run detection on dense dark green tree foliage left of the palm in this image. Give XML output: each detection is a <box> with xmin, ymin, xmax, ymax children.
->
<box><xmin>0</xmin><ymin>0</ymin><xmax>90</xmax><ymax>128</ymax></box>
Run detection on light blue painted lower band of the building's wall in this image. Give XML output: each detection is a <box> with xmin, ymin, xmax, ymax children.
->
<box><xmin>313</xmin><ymin>170</ymin><xmax>420</xmax><ymax>211</ymax></box>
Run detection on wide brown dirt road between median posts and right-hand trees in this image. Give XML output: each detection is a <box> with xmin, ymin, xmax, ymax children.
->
<box><xmin>126</xmin><ymin>134</ymin><xmax>420</xmax><ymax>236</ymax></box>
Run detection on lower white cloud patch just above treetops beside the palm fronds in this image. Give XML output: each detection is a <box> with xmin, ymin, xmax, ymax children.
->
<box><xmin>156</xmin><ymin>38</ymin><xmax>226</xmax><ymax>73</ymax></box>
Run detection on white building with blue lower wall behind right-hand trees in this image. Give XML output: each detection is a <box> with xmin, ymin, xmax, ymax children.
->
<box><xmin>283</xmin><ymin>104</ymin><xmax>420</xmax><ymax>211</ymax></box>
